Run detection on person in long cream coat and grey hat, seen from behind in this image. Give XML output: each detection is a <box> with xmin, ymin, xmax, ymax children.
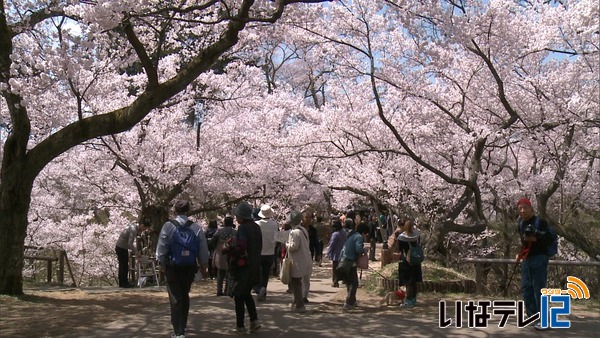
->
<box><xmin>287</xmin><ymin>210</ymin><xmax>312</xmax><ymax>313</ymax></box>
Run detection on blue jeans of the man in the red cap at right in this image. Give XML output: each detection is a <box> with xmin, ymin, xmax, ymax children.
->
<box><xmin>521</xmin><ymin>255</ymin><xmax>549</xmax><ymax>317</ymax></box>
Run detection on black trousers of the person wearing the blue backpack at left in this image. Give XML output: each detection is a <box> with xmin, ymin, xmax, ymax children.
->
<box><xmin>165</xmin><ymin>266</ymin><xmax>198</xmax><ymax>335</ymax></box>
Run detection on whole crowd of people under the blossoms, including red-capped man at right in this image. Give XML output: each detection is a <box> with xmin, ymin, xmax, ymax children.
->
<box><xmin>115</xmin><ymin>199</ymin><xmax>550</xmax><ymax>338</ymax></box>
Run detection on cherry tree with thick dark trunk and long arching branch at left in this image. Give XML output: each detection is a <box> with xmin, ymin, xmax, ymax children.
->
<box><xmin>0</xmin><ymin>0</ymin><xmax>330</xmax><ymax>294</ymax></box>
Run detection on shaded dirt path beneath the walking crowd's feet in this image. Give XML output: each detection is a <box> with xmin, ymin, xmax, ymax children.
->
<box><xmin>0</xmin><ymin>265</ymin><xmax>600</xmax><ymax>338</ymax></box>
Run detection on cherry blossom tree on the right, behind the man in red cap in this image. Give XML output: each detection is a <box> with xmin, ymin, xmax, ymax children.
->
<box><xmin>258</xmin><ymin>1</ymin><xmax>599</xmax><ymax>257</ymax></box>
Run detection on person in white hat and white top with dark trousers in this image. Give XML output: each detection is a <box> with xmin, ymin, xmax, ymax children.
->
<box><xmin>253</xmin><ymin>204</ymin><xmax>279</xmax><ymax>301</ymax></box>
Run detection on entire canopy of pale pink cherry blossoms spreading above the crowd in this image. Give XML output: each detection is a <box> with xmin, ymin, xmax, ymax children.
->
<box><xmin>0</xmin><ymin>0</ymin><xmax>600</xmax><ymax>292</ymax></box>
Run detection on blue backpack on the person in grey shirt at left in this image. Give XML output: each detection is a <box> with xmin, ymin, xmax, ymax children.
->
<box><xmin>169</xmin><ymin>220</ymin><xmax>200</xmax><ymax>266</ymax></box>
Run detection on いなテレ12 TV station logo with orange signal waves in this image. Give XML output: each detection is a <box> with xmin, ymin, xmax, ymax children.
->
<box><xmin>439</xmin><ymin>276</ymin><xmax>590</xmax><ymax>329</ymax></box>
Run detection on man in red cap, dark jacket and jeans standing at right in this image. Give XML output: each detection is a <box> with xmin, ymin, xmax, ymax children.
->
<box><xmin>516</xmin><ymin>198</ymin><xmax>552</xmax><ymax>330</ymax></box>
